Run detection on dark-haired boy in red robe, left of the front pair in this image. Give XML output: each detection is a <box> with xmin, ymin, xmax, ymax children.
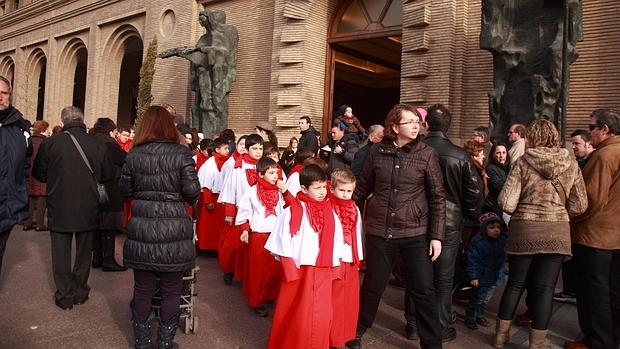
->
<box><xmin>265</xmin><ymin>165</ymin><xmax>344</xmax><ymax>349</ymax></box>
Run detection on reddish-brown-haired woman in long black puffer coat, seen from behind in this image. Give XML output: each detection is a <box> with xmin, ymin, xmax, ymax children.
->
<box><xmin>119</xmin><ymin>106</ymin><xmax>200</xmax><ymax>348</ymax></box>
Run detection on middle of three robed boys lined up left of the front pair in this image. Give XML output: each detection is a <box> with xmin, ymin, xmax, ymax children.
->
<box><xmin>218</xmin><ymin>134</ymin><xmax>263</xmax><ymax>285</ymax></box>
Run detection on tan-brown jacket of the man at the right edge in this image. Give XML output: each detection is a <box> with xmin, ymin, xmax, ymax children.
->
<box><xmin>571</xmin><ymin>136</ymin><xmax>620</xmax><ymax>250</ymax></box>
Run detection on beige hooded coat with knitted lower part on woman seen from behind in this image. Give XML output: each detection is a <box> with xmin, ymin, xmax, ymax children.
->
<box><xmin>498</xmin><ymin>147</ymin><xmax>588</xmax><ymax>255</ymax></box>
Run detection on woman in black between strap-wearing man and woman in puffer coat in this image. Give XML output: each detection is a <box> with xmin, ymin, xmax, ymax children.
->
<box><xmin>90</xmin><ymin>118</ymin><xmax>127</xmax><ymax>271</ymax></box>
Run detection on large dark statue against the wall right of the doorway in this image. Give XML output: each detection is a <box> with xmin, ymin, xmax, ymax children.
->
<box><xmin>480</xmin><ymin>0</ymin><xmax>582</xmax><ymax>140</ymax></box>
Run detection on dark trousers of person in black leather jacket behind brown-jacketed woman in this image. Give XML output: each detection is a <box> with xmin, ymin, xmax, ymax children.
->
<box><xmin>405</xmin><ymin>231</ymin><xmax>461</xmax><ymax>329</ymax></box>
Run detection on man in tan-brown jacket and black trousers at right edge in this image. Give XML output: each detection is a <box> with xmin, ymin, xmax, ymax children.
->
<box><xmin>565</xmin><ymin>109</ymin><xmax>620</xmax><ymax>349</ymax></box>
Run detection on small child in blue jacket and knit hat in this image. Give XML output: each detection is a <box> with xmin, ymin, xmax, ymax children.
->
<box><xmin>465</xmin><ymin>212</ymin><xmax>506</xmax><ymax>330</ymax></box>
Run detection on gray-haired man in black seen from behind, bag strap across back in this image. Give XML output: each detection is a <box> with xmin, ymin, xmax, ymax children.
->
<box><xmin>32</xmin><ymin>107</ymin><xmax>114</xmax><ymax>310</ymax></box>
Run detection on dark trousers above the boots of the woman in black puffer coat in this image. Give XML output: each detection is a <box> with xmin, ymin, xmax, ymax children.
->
<box><xmin>133</xmin><ymin>269</ymin><xmax>183</xmax><ymax>323</ymax></box>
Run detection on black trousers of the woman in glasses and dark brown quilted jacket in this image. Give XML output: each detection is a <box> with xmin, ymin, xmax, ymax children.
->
<box><xmin>357</xmin><ymin>235</ymin><xmax>442</xmax><ymax>348</ymax></box>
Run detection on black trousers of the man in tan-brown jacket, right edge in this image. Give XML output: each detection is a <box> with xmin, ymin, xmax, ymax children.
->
<box><xmin>573</xmin><ymin>244</ymin><xmax>620</xmax><ymax>349</ymax></box>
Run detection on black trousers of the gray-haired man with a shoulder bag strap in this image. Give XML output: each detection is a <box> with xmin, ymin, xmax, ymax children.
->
<box><xmin>50</xmin><ymin>231</ymin><xmax>93</xmax><ymax>306</ymax></box>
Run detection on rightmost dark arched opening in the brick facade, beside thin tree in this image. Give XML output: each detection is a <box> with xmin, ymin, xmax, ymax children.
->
<box><xmin>117</xmin><ymin>36</ymin><xmax>143</xmax><ymax>126</ymax></box>
